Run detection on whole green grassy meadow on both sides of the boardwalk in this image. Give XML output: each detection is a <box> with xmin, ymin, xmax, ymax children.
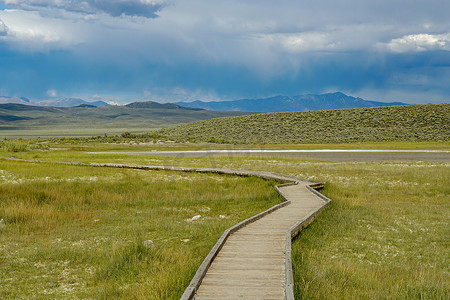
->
<box><xmin>0</xmin><ymin>143</ymin><xmax>450</xmax><ymax>299</ymax></box>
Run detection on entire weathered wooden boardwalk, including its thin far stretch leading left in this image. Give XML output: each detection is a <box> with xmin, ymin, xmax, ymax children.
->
<box><xmin>3</xmin><ymin>157</ymin><xmax>331</xmax><ymax>300</ymax></box>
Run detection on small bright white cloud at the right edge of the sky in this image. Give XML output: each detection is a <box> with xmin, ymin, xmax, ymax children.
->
<box><xmin>381</xmin><ymin>32</ymin><xmax>450</xmax><ymax>53</ymax></box>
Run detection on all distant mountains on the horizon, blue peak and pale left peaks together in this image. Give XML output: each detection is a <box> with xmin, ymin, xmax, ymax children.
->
<box><xmin>0</xmin><ymin>92</ymin><xmax>406</xmax><ymax>113</ymax></box>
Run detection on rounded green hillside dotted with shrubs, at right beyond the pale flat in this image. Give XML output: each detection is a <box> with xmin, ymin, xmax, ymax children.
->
<box><xmin>155</xmin><ymin>103</ymin><xmax>450</xmax><ymax>144</ymax></box>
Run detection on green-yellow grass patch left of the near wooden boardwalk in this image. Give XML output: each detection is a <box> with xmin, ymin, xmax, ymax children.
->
<box><xmin>0</xmin><ymin>161</ymin><xmax>281</xmax><ymax>299</ymax></box>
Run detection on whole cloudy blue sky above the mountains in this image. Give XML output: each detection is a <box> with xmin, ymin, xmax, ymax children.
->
<box><xmin>0</xmin><ymin>0</ymin><xmax>450</xmax><ymax>103</ymax></box>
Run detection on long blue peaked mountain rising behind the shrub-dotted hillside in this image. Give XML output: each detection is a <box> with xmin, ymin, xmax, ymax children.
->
<box><xmin>174</xmin><ymin>92</ymin><xmax>407</xmax><ymax>113</ymax></box>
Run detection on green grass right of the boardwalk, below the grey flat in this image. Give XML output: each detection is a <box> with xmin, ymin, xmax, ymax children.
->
<box><xmin>292</xmin><ymin>163</ymin><xmax>450</xmax><ymax>299</ymax></box>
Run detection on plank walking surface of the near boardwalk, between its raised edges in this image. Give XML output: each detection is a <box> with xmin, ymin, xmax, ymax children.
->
<box><xmin>195</xmin><ymin>182</ymin><xmax>324</xmax><ymax>300</ymax></box>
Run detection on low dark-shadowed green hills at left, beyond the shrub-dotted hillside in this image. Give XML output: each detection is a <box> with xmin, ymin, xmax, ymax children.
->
<box><xmin>0</xmin><ymin>102</ymin><xmax>250</xmax><ymax>138</ymax></box>
